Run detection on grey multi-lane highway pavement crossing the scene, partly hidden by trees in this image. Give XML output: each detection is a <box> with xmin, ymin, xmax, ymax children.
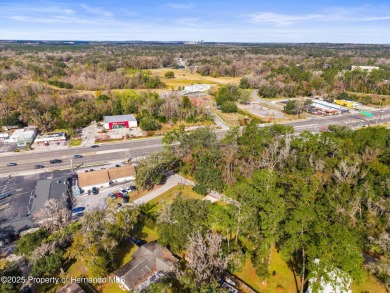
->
<box><xmin>0</xmin><ymin>108</ymin><xmax>390</xmax><ymax>177</ymax></box>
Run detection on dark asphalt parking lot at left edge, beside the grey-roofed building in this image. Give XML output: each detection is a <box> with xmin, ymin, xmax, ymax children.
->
<box><xmin>0</xmin><ymin>171</ymin><xmax>68</xmax><ymax>223</ymax></box>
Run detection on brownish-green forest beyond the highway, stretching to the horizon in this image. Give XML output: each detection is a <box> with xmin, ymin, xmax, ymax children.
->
<box><xmin>0</xmin><ymin>43</ymin><xmax>390</xmax><ymax>130</ymax></box>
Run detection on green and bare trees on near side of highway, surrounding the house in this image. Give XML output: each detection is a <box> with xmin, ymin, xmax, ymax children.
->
<box><xmin>0</xmin><ymin>123</ymin><xmax>390</xmax><ymax>292</ymax></box>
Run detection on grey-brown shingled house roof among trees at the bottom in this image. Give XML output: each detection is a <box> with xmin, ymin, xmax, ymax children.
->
<box><xmin>114</xmin><ymin>241</ymin><xmax>178</xmax><ymax>288</ymax></box>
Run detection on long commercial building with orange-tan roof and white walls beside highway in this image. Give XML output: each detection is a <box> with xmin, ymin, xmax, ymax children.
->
<box><xmin>77</xmin><ymin>165</ymin><xmax>135</xmax><ymax>191</ymax></box>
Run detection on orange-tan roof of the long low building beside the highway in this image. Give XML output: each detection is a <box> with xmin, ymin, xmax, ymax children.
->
<box><xmin>78</xmin><ymin>165</ymin><xmax>135</xmax><ymax>188</ymax></box>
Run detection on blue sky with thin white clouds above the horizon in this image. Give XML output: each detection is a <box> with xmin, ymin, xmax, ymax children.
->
<box><xmin>0</xmin><ymin>0</ymin><xmax>390</xmax><ymax>44</ymax></box>
